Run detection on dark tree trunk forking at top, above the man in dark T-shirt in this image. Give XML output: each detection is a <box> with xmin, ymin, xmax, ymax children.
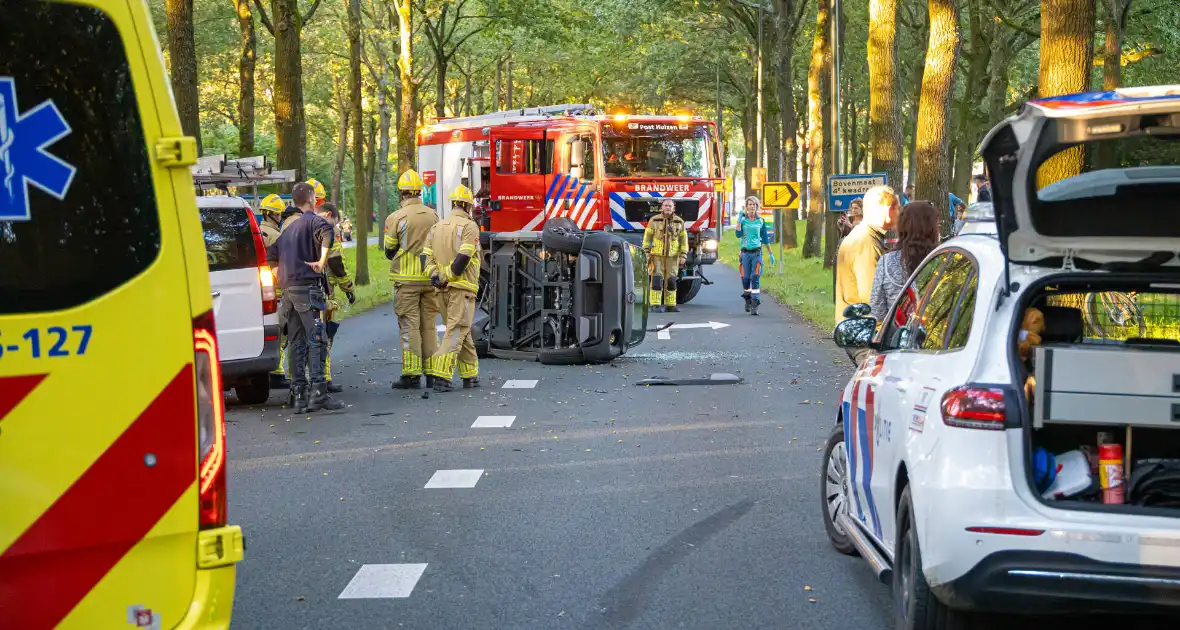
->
<box><xmin>254</xmin><ymin>0</ymin><xmax>320</xmax><ymax>179</ymax></box>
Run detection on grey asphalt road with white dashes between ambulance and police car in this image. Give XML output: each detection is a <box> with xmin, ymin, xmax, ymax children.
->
<box><xmin>221</xmin><ymin>267</ymin><xmax>892</xmax><ymax>630</ymax></box>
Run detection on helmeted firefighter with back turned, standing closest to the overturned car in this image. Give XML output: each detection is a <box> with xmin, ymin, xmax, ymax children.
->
<box><xmin>422</xmin><ymin>184</ymin><xmax>479</xmax><ymax>392</ymax></box>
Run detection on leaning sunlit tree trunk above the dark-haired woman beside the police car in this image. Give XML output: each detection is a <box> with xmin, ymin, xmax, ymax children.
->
<box><xmin>915</xmin><ymin>0</ymin><xmax>961</xmax><ymax>223</ymax></box>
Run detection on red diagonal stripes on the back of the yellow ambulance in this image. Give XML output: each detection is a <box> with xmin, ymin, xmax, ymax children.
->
<box><xmin>0</xmin><ymin>363</ymin><xmax>197</xmax><ymax>629</ymax></box>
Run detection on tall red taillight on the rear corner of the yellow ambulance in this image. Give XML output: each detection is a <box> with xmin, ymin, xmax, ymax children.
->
<box><xmin>192</xmin><ymin>311</ymin><xmax>227</xmax><ymax>529</ymax></box>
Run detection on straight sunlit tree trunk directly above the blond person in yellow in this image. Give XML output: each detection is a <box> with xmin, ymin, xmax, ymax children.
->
<box><xmin>867</xmin><ymin>0</ymin><xmax>903</xmax><ymax>189</ymax></box>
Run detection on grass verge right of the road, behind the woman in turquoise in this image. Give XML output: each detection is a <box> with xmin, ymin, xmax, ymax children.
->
<box><xmin>719</xmin><ymin>221</ymin><xmax>835</xmax><ymax>332</ymax></box>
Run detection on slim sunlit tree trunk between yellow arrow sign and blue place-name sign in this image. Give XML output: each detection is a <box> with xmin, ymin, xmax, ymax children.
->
<box><xmin>802</xmin><ymin>0</ymin><xmax>832</xmax><ymax>258</ymax></box>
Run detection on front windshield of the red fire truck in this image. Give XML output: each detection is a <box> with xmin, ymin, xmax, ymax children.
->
<box><xmin>602</xmin><ymin>122</ymin><xmax>712</xmax><ymax>177</ymax></box>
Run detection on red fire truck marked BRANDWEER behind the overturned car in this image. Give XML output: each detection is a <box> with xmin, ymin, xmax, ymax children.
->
<box><xmin>418</xmin><ymin>105</ymin><xmax>725</xmax><ymax>303</ymax></box>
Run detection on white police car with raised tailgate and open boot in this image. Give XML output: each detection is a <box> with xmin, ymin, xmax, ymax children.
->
<box><xmin>820</xmin><ymin>86</ymin><xmax>1180</xmax><ymax>629</ymax></box>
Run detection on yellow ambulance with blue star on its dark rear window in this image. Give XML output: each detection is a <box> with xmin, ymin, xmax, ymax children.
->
<box><xmin>0</xmin><ymin>0</ymin><xmax>243</xmax><ymax>630</ymax></box>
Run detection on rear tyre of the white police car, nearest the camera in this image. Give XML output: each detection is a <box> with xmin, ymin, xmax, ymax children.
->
<box><xmin>893</xmin><ymin>486</ymin><xmax>994</xmax><ymax>630</ymax></box>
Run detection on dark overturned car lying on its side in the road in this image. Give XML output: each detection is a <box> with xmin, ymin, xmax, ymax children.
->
<box><xmin>472</xmin><ymin>217</ymin><xmax>648</xmax><ymax>365</ymax></box>
